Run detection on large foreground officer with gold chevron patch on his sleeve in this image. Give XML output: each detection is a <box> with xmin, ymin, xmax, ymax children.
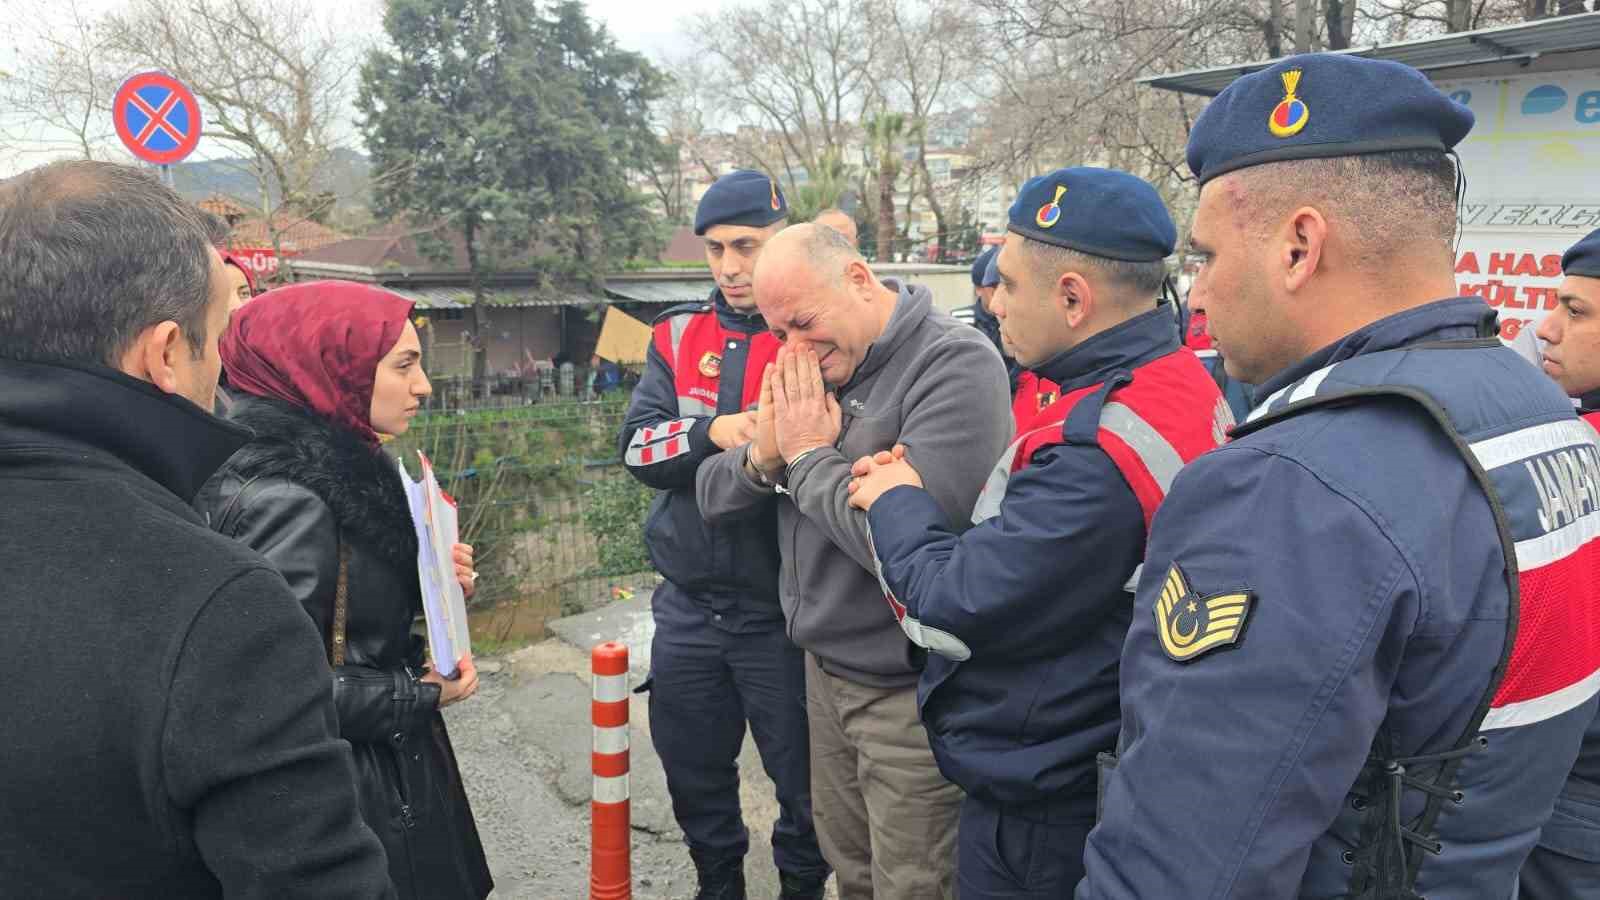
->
<box><xmin>1077</xmin><ymin>54</ymin><xmax>1600</xmax><ymax>900</ymax></box>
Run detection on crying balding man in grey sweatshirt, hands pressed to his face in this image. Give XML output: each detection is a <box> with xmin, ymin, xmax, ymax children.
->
<box><xmin>696</xmin><ymin>224</ymin><xmax>1011</xmax><ymax>900</ymax></box>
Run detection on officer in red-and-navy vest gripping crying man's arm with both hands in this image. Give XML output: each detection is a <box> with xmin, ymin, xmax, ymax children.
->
<box><xmin>851</xmin><ymin>168</ymin><xmax>1234</xmax><ymax>900</ymax></box>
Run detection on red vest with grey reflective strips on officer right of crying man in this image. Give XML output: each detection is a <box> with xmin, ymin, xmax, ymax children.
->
<box><xmin>878</xmin><ymin>348</ymin><xmax>1234</xmax><ymax>660</ymax></box>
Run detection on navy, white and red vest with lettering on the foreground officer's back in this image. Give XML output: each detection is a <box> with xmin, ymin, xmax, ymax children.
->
<box><xmin>1232</xmin><ymin>338</ymin><xmax>1600</xmax><ymax>900</ymax></box>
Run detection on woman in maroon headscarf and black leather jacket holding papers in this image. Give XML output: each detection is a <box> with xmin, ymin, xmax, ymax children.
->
<box><xmin>195</xmin><ymin>282</ymin><xmax>493</xmax><ymax>900</ymax></box>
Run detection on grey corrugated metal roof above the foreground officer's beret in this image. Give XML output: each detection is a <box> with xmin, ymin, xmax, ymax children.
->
<box><xmin>1139</xmin><ymin>13</ymin><xmax>1600</xmax><ymax>96</ymax></box>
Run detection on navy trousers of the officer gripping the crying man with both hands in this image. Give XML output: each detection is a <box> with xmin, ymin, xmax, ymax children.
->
<box><xmin>958</xmin><ymin>798</ymin><xmax>1094</xmax><ymax>900</ymax></box>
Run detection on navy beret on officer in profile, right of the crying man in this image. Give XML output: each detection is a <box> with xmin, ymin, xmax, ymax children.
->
<box><xmin>1011</xmin><ymin>167</ymin><xmax>1178</xmax><ymax>263</ymax></box>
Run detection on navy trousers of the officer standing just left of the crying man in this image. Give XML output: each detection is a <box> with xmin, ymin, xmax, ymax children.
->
<box><xmin>650</xmin><ymin>585</ymin><xmax>827</xmax><ymax>878</ymax></box>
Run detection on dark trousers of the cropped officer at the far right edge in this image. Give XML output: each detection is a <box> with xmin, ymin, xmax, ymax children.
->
<box><xmin>1517</xmin><ymin>778</ymin><xmax>1600</xmax><ymax>900</ymax></box>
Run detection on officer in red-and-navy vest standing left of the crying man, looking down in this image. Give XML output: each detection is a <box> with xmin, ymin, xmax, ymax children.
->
<box><xmin>618</xmin><ymin>171</ymin><xmax>829</xmax><ymax>900</ymax></box>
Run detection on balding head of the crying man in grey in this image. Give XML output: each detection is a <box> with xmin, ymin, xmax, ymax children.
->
<box><xmin>755</xmin><ymin>223</ymin><xmax>899</xmax><ymax>386</ymax></box>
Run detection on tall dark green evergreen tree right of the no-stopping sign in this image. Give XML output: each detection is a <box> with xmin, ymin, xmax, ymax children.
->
<box><xmin>357</xmin><ymin>0</ymin><xmax>669</xmax><ymax>381</ymax></box>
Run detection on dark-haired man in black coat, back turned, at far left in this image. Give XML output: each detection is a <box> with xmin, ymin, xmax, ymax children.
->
<box><xmin>0</xmin><ymin>162</ymin><xmax>392</xmax><ymax>900</ymax></box>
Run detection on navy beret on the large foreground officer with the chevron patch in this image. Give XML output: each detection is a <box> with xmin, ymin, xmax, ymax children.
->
<box><xmin>1189</xmin><ymin>53</ymin><xmax>1472</xmax><ymax>184</ymax></box>
